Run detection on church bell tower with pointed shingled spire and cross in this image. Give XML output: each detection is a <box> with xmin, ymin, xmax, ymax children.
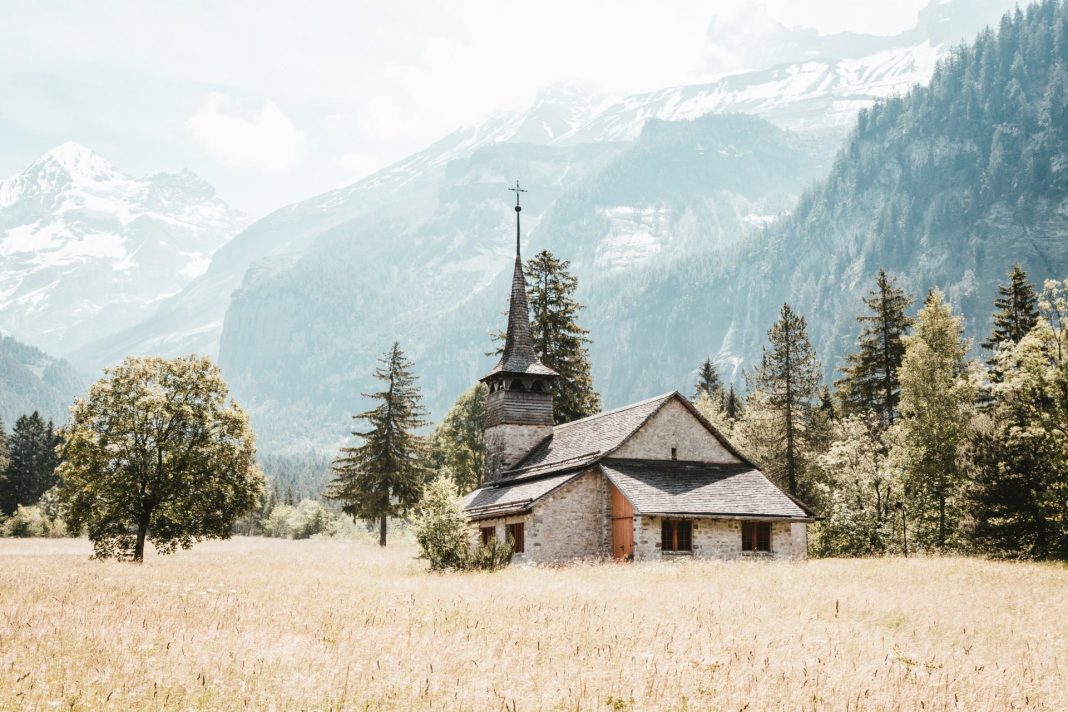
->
<box><xmin>481</xmin><ymin>181</ymin><xmax>557</xmax><ymax>484</ymax></box>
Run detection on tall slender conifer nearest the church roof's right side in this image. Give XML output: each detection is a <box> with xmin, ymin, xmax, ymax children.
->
<box><xmin>748</xmin><ymin>304</ymin><xmax>820</xmax><ymax>496</ymax></box>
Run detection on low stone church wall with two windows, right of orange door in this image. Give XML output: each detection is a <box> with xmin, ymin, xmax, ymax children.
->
<box><xmin>634</xmin><ymin>516</ymin><xmax>808</xmax><ymax>560</ymax></box>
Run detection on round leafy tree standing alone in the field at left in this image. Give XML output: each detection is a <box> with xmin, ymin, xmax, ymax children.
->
<box><xmin>59</xmin><ymin>357</ymin><xmax>264</xmax><ymax>563</ymax></box>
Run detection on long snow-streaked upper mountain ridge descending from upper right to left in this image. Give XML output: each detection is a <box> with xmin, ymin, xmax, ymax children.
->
<box><xmin>70</xmin><ymin>0</ymin><xmax>1010</xmax><ymax>369</ymax></box>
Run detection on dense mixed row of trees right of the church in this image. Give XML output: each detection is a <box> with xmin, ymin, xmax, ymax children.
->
<box><xmin>695</xmin><ymin>266</ymin><xmax>1068</xmax><ymax>558</ymax></box>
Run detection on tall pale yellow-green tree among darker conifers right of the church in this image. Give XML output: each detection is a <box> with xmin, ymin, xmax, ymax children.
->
<box><xmin>890</xmin><ymin>289</ymin><xmax>975</xmax><ymax>550</ymax></box>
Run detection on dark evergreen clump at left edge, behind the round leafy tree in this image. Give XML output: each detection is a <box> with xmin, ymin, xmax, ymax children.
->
<box><xmin>0</xmin><ymin>411</ymin><xmax>61</xmax><ymax>513</ymax></box>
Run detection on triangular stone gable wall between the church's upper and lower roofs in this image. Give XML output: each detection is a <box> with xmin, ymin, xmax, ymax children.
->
<box><xmin>612</xmin><ymin>399</ymin><xmax>739</xmax><ymax>462</ymax></box>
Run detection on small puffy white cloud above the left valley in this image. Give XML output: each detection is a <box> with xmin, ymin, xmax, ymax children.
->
<box><xmin>186</xmin><ymin>92</ymin><xmax>304</xmax><ymax>173</ymax></box>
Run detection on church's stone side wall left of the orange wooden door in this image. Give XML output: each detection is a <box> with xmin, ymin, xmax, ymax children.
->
<box><xmin>471</xmin><ymin>470</ymin><xmax>612</xmax><ymax>564</ymax></box>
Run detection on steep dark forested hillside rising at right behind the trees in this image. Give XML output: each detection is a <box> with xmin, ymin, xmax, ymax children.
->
<box><xmin>590</xmin><ymin>0</ymin><xmax>1068</xmax><ymax>394</ymax></box>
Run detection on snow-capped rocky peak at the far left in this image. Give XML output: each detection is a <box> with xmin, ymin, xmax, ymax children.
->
<box><xmin>0</xmin><ymin>143</ymin><xmax>247</xmax><ymax>354</ymax></box>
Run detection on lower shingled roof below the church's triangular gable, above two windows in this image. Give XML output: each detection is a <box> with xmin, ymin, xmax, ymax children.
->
<box><xmin>598</xmin><ymin>459</ymin><xmax>815</xmax><ymax>521</ymax></box>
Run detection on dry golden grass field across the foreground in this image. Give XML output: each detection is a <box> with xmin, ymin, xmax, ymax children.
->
<box><xmin>0</xmin><ymin>539</ymin><xmax>1068</xmax><ymax>711</ymax></box>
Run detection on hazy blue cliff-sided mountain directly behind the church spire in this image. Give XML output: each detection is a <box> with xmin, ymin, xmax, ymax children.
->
<box><xmin>220</xmin><ymin>116</ymin><xmax>827</xmax><ymax>442</ymax></box>
